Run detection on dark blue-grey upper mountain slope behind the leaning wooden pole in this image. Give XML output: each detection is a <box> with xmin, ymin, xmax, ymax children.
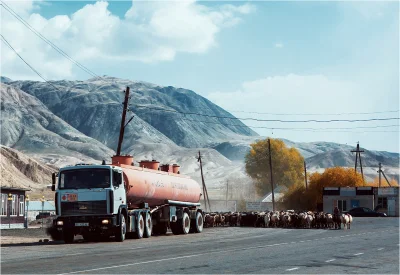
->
<box><xmin>10</xmin><ymin>77</ymin><xmax>257</xmax><ymax>148</ymax></box>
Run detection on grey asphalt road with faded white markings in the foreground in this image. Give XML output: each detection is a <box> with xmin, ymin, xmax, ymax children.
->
<box><xmin>1</xmin><ymin>218</ymin><xmax>399</xmax><ymax>274</ymax></box>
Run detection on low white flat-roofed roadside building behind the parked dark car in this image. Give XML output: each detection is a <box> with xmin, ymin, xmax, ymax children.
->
<box><xmin>322</xmin><ymin>186</ymin><xmax>399</xmax><ymax>217</ymax></box>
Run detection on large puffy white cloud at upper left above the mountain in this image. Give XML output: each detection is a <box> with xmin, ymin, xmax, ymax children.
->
<box><xmin>1</xmin><ymin>1</ymin><xmax>254</xmax><ymax>79</ymax></box>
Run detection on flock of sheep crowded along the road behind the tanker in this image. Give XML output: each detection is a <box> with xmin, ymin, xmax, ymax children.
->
<box><xmin>204</xmin><ymin>210</ymin><xmax>353</xmax><ymax>229</ymax></box>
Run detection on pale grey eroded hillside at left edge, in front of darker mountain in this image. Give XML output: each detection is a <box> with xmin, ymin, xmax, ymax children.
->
<box><xmin>0</xmin><ymin>84</ymin><xmax>114</xmax><ymax>162</ymax></box>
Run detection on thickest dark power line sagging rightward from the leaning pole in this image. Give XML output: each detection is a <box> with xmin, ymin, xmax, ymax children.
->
<box><xmin>133</xmin><ymin>105</ymin><xmax>399</xmax><ymax>123</ymax></box>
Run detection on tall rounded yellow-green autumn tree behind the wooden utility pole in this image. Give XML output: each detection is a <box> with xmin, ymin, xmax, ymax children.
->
<box><xmin>245</xmin><ymin>139</ymin><xmax>304</xmax><ymax>196</ymax></box>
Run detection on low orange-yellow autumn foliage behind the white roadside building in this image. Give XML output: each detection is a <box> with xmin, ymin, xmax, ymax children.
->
<box><xmin>283</xmin><ymin>167</ymin><xmax>364</xmax><ymax>210</ymax></box>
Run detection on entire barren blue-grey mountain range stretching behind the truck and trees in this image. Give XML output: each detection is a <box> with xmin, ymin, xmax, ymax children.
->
<box><xmin>1</xmin><ymin>76</ymin><xmax>399</xmax><ymax>197</ymax></box>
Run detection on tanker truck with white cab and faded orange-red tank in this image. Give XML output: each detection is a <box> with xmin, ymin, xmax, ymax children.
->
<box><xmin>52</xmin><ymin>155</ymin><xmax>203</xmax><ymax>243</ymax></box>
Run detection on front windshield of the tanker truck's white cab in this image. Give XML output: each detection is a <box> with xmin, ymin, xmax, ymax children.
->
<box><xmin>59</xmin><ymin>168</ymin><xmax>111</xmax><ymax>189</ymax></box>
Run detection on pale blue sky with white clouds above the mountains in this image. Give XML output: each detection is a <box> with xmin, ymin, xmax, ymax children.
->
<box><xmin>0</xmin><ymin>1</ymin><xmax>400</xmax><ymax>152</ymax></box>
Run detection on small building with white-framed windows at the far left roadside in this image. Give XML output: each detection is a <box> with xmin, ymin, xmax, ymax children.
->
<box><xmin>0</xmin><ymin>187</ymin><xmax>29</xmax><ymax>229</ymax></box>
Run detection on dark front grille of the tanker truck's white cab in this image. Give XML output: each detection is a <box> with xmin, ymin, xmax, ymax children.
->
<box><xmin>61</xmin><ymin>200</ymin><xmax>107</xmax><ymax>215</ymax></box>
